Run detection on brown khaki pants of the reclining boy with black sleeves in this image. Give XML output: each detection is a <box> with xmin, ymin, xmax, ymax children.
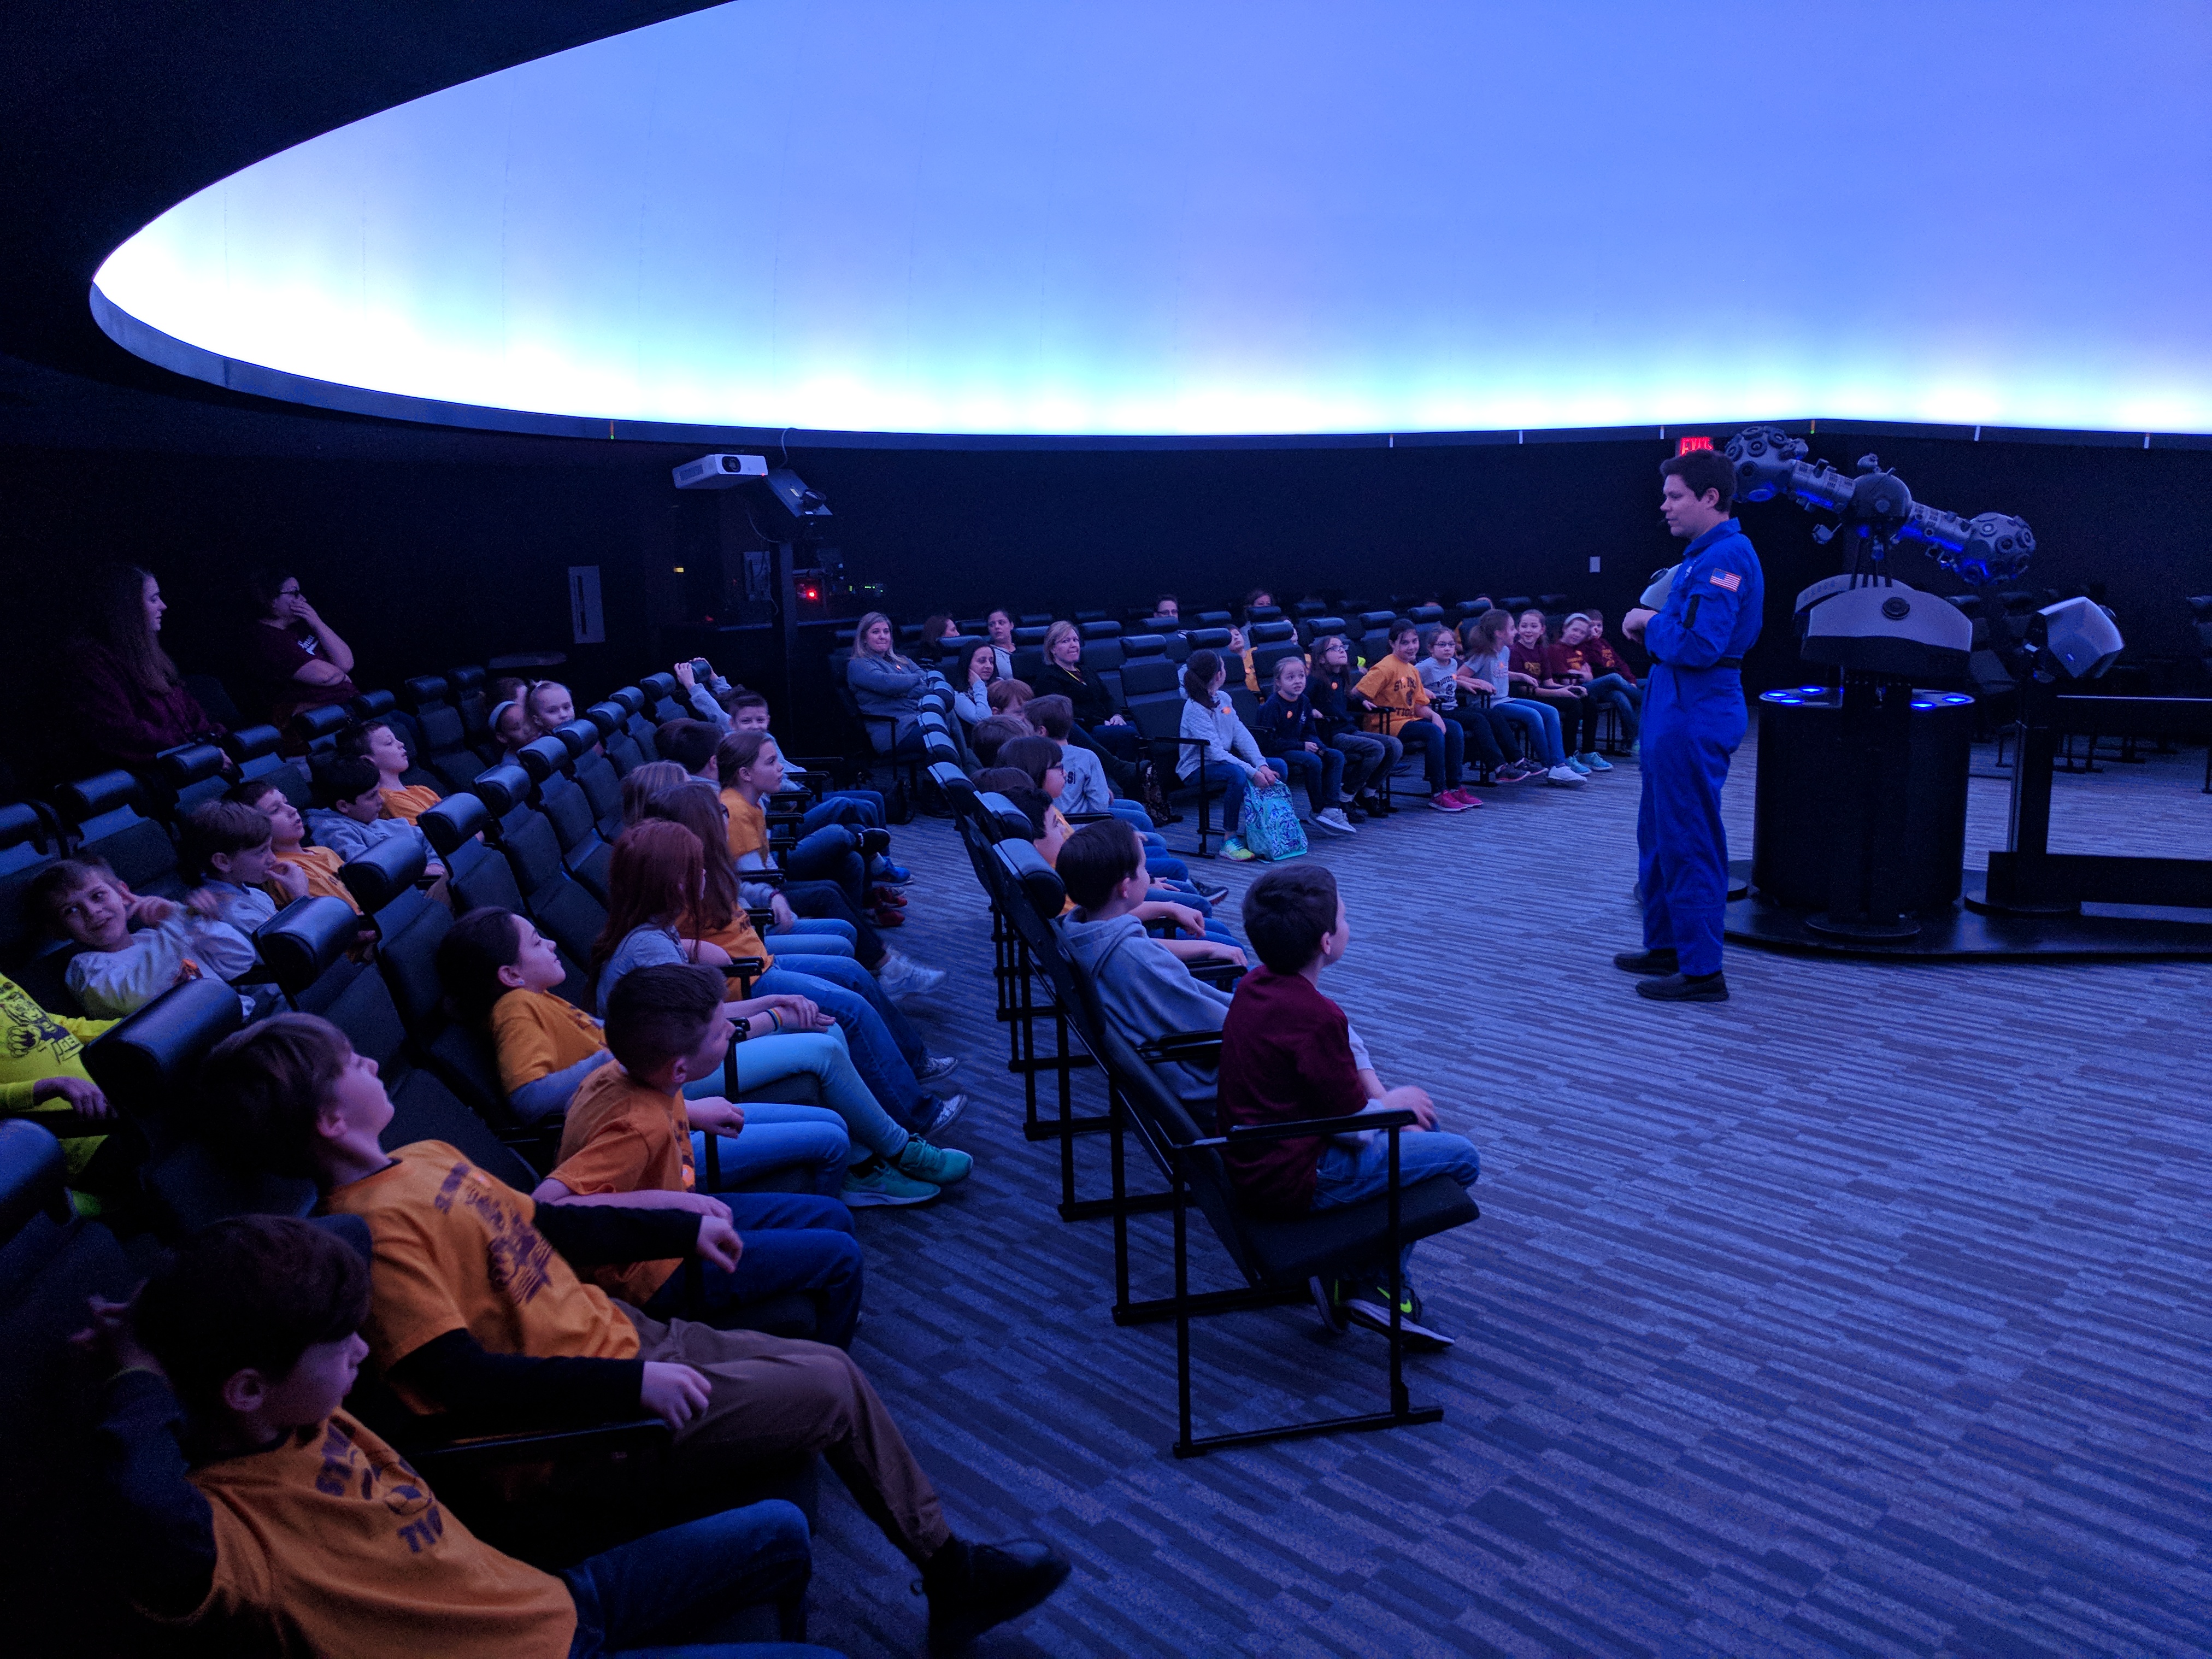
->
<box><xmin>615</xmin><ymin>1303</ymin><xmax>951</xmax><ymax>1566</ymax></box>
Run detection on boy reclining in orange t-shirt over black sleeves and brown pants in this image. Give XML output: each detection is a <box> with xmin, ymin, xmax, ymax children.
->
<box><xmin>199</xmin><ymin>1008</ymin><xmax>1068</xmax><ymax>1659</ymax></box>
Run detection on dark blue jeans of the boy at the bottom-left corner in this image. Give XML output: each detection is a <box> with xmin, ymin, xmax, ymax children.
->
<box><xmin>560</xmin><ymin>1500</ymin><xmax>834</xmax><ymax>1659</ymax></box>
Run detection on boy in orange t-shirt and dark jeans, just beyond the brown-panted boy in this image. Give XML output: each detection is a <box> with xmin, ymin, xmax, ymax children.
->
<box><xmin>531</xmin><ymin>962</ymin><xmax>871</xmax><ymax>1347</ymax></box>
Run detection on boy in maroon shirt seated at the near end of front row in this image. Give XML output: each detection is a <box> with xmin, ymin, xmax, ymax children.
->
<box><xmin>1221</xmin><ymin>865</ymin><xmax>1482</xmax><ymax>1349</ymax></box>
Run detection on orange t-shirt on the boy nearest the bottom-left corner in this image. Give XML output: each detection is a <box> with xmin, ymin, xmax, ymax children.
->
<box><xmin>186</xmin><ymin>1415</ymin><xmax>575</xmax><ymax>1659</ymax></box>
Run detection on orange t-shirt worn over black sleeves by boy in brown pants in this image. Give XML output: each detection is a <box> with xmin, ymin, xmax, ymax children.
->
<box><xmin>323</xmin><ymin>1142</ymin><xmax>637</xmax><ymax>1411</ymax></box>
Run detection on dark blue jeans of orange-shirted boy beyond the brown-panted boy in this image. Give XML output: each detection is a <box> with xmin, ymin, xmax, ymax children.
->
<box><xmin>646</xmin><ymin>1194</ymin><xmax>861</xmax><ymax>1347</ymax></box>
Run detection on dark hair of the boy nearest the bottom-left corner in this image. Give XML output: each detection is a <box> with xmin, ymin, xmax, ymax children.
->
<box><xmin>131</xmin><ymin>1214</ymin><xmax>369</xmax><ymax>1416</ymax></box>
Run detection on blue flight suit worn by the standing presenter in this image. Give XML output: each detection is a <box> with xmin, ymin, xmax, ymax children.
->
<box><xmin>1637</xmin><ymin>517</ymin><xmax>1765</xmax><ymax>973</ymax></box>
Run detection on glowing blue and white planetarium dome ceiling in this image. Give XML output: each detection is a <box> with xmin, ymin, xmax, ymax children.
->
<box><xmin>95</xmin><ymin>0</ymin><xmax>2212</xmax><ymax>438</ymax></box>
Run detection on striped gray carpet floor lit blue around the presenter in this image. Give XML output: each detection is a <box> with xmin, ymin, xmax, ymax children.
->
<box><xmin>787</xmin><ymin>748</ymin><xmax>2212</xmax><ymax>1659</ymax></box>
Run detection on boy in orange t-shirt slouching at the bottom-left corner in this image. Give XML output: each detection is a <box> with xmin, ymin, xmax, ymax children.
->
<box><xmin>78</xmin><ymin>1216</ymin><xmax>827</xmax><ymax>1659</ymax></box>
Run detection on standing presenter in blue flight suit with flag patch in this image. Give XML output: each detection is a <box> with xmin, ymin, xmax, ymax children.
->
<box><xmin>1613</xmin><ymin>449</ymin><xmax>1765</xmax><ymax>1002</ymax></box>
